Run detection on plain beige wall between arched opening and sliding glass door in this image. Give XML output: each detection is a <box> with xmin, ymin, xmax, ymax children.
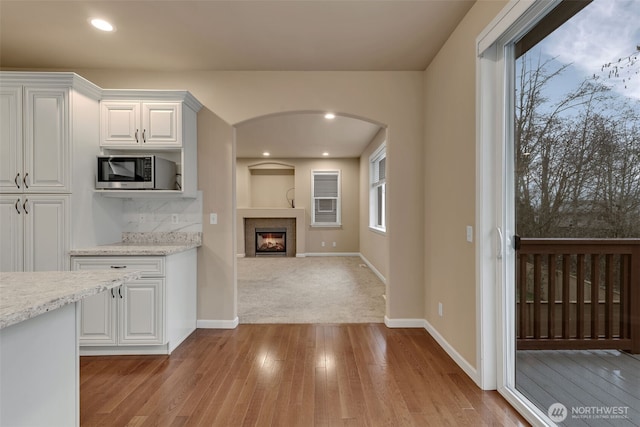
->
<box><xmin>423</xmin><ymin>1</ymin><xmax>506</xmax><ymax>366</ymax></box>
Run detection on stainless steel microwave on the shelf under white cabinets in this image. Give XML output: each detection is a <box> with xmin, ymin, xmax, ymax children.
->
<box><xmin>96</xmin><ymin>155</ymin><xmax>176</xmax><ymax>190</ymax></box>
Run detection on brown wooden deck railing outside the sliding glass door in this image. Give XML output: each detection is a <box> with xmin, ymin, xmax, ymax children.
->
<box><xmin>516</xmin><ymin>238</ymin><xmax>640</xmax><ymax>353</ymax></box>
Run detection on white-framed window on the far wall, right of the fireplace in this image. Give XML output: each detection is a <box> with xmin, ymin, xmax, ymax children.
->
<box><xmin>311</xmin><ymin>171</ymin><xmax>340</xmax><ymax>227</ymax></box>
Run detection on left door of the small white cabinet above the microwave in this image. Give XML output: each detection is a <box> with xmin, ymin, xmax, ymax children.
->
<box><xmin>100</xmin><ymin>101</ymin><xmax>142</xmax><ymax>146</ymax></box>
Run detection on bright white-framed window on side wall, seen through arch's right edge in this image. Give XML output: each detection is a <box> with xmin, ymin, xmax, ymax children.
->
<box><xmin>369</xmin><ymin>144</ymin><xmax>387</xmax><ymax>232</ymax></box>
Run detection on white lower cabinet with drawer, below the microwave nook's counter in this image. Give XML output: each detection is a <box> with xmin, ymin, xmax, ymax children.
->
<box><xmin>71</xmin><ymin>249</ymin><xmax>196</xmax><ymax>355</ymax></box>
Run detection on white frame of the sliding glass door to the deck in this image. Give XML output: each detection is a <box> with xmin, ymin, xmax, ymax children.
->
<box><xmin>476</xmin><ymin>0</ymin><xmax>560</xmax><ymax>426</ymax></box>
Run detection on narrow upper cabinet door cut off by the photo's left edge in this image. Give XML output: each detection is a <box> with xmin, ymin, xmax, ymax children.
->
<box><xmin>0</xmin><ymin>86</ymin><xmax>22</xmax><ymax>193</ymax></box>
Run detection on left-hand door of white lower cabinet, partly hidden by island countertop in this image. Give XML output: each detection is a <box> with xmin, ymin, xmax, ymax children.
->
<box><xmin>79</xmin><ymin>287</ymin><xmax>121</xmax><ymax>345</ymax></box>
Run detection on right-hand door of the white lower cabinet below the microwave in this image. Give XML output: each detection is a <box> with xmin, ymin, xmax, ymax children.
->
<box><xmin>118</xmin><ymin>278</ymin><xmax>164</xmax><ymax>345</ymax></box>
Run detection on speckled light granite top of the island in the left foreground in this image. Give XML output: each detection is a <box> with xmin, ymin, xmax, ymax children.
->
<box><xmin>0</xmin><ymin>270</ymin><xmax>140</xmax><ymax>329</ymax></box>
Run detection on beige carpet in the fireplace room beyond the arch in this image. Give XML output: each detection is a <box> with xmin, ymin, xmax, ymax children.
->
<box><xmin>238</xmin><ymin>257</ymin><xmax>385</xmax><ymax>323</ymax></box>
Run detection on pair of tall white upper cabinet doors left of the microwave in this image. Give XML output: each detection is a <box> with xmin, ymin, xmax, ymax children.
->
<box><xmin>0</xmin><ymin>84</ymin><xmax>71</xmax><ymax>193</ymax></box>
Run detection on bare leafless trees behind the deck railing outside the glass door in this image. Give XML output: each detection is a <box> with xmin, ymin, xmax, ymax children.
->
<box><xmin>515</xmin><ymin>55</ymin><xmax>640</xmax><ymax>237</ymax></box>
